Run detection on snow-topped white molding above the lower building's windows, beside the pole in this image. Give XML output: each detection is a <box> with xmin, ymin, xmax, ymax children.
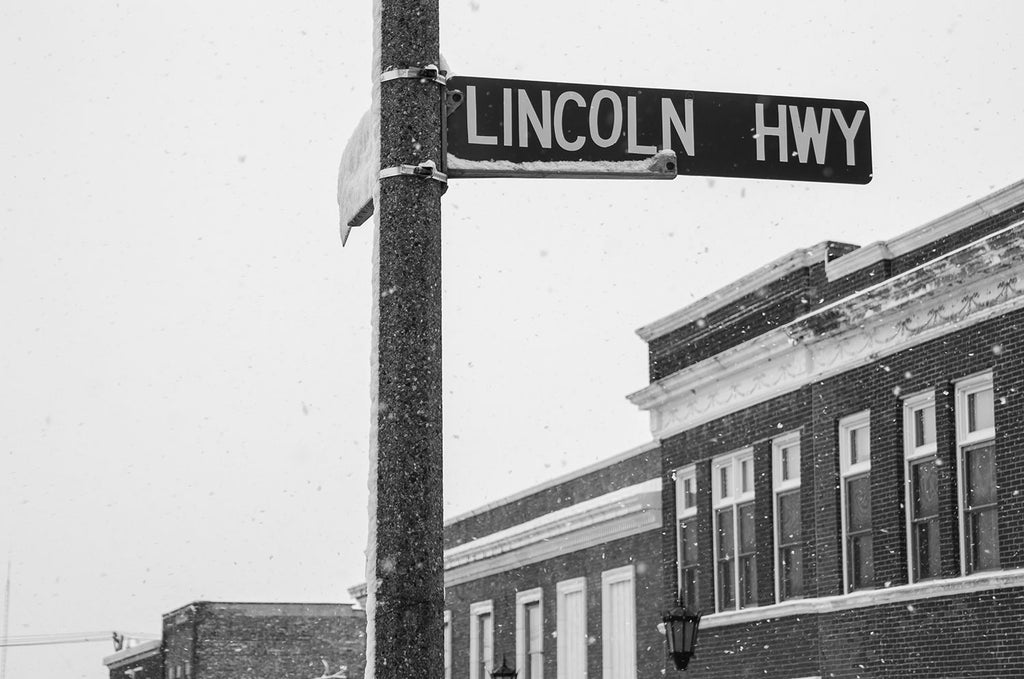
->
<box><xmin>444</xmin><ymin>478</ymin><xmax>662</xmax><ymax>587</ymax></box>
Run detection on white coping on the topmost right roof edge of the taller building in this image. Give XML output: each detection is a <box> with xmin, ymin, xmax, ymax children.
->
<box><xmin>825</xmin><ymin>180</ymin><xmax>1024</xmax><ymax>281</ymax></box>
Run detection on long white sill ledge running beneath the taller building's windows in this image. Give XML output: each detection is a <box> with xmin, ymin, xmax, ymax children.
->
<box><xmin>700</xmin><ymin>568</ymin><xmax>1024</xmax><ymax>631</ymax></box>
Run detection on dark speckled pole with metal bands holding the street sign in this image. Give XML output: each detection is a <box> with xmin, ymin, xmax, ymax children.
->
<box><xmin>366</xmin><ymin>0</ymin><xmax>445</xmax><ymax>679</ymax></box>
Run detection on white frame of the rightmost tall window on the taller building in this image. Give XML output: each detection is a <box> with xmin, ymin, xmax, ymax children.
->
<box><xmin>954</xmin><ymin>371</ymin><xmax>1001</xmax><ymax>576</ymax></box>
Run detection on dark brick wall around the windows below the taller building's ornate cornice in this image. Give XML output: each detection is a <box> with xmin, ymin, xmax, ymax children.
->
<box><xmin>662</xmin><ymin>310</ymin><xmax>1024</xmax><ymax>679</ymax></box>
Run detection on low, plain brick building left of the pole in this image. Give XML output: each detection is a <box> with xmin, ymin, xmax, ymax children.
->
<box><xmin>103</xmin><ymin>601</ymin><xmax>366</xmax><ymax>679</ymax></box>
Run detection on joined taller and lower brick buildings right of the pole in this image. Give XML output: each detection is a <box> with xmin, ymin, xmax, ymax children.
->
<box><xmin>350</xmin><ymin>176</ymin><xmax>1024</xmax><ymax>679</ymax></box>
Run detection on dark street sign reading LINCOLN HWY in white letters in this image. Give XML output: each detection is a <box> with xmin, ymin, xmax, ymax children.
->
<box><xmin>446</xmin><ymin>76</ymin><xmax>871</xmax><ymax>184</ymax></box>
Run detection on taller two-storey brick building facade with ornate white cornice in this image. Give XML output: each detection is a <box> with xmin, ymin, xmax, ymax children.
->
<box><xmin>631</xmin><ymin>176</ymin><xmax>1024</xmax><ymax>679</ymax></box>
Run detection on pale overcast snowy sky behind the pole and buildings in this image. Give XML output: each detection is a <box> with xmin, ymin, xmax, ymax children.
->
<box><xmin>0</xmin><ymin>0</ymin><xmax>1024</xmax><ymax>679</ymax></box>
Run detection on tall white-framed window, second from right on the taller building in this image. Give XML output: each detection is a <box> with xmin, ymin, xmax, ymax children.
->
<box><xmin>903</xmin><ymin>392</ymin><xmax>941</xmax><ymax>582</ymax></box>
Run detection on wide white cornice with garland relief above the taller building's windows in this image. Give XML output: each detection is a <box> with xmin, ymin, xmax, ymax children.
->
<box><xmin>629</xmin><ymin>220</ymin><xmax>1024</xmax><ymax>439</ymax></box>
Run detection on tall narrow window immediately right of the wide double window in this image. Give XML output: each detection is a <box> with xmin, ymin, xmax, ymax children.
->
<box><xmin>772</xmin><ymin>432</ymin><xmax>804</xmax><ymax>601</ymax></box>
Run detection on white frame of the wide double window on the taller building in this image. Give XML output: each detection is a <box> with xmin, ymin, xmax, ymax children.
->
<box><xmin>711</xmin><ymin>447</ymin><xmax>758</xmax><ymax>612</ymax></box>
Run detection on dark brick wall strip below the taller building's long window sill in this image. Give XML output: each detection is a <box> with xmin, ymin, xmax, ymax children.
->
<box><xmin>684</xmin><ymin>588</ymin><xmax>1024</xmax><ymax>679</ymax></box>
